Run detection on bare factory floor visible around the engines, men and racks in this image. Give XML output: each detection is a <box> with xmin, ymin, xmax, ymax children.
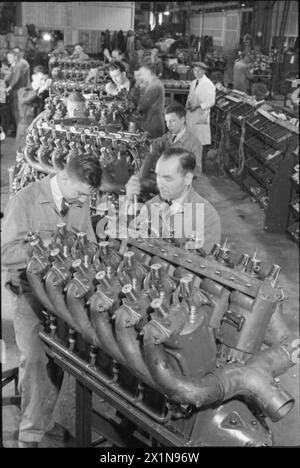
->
<box><xmin>1</xmin><ymin>138</ymin><xmax>300</xmax><ymax>447</ymax></box>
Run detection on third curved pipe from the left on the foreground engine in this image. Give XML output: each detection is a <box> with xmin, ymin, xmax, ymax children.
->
<box><xmin>66</xmin><ymin>278</ymin><xmax>100</xmax><ymax>347</ymax></box>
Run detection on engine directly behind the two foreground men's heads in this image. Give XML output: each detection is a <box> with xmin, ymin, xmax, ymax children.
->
<box><xmin>9</xmin><ymin>106</ymin><xmax>150</xmax><ymax>216</ymax></box>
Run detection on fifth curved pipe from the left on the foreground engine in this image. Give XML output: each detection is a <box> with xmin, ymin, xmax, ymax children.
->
<box><xmin>114</xmin><ymin>305</ymin><xmax>156</xmax><ymax>388</ymax></box>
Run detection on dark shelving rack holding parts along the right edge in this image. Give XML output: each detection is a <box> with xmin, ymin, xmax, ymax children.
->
<box><xmin>211</xmin><ymin>91</ymin><xmax>298</xmax><ymax>233</ymax></box>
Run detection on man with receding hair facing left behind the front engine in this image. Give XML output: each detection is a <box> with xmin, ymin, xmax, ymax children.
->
<box><xmin>120</xmin><ymin>148</ymin><xmax>221</xmax><ymax>254</ymax></box>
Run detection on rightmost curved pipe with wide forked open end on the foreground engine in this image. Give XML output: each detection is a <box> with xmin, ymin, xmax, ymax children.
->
<box><xmin>143</xmin><ymin>322</ymin><xmax>294</xmax><ymax>421</ymax></box>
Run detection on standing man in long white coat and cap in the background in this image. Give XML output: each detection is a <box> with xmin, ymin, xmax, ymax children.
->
<box><xmin>185</xmin><ymin>62</ymin><xmax>216</xmax><ymax>171</ymax></box>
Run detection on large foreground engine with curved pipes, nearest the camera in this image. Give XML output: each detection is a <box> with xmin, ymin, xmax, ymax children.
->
<box><xmin>27</xmin><ymin>228</ymin><xmax>298</xmax><ymax>447</ymax></box>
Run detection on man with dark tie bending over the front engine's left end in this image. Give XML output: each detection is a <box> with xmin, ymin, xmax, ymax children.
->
<box><xmin>1</xmin><ymin>154</ymin><xmax>102</xmax><ymax>448</ymax></box>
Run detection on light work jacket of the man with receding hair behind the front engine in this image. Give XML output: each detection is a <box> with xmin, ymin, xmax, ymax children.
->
<box><xmin>106</xmin><ymin>186</ymin><xmax>221</xmax><ymax>253</ymax></box>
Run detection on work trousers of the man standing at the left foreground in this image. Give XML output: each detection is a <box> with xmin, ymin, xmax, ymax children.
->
<box><xmin>14</xmin><ymin>292</ymin><xmax>58</xmax><ymax>442</ymax></box>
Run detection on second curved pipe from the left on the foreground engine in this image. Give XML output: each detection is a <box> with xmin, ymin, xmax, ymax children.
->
<box><xmin>45</xmin><ymin>269</ymin><xmax>81</xmax><ymax>333</ymax></box>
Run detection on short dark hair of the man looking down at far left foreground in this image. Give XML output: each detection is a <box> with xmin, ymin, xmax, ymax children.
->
<box><xmin>65</xmin><ymin>153</ymin><xmax>102</xmax><ymax>189</ymax></box>
